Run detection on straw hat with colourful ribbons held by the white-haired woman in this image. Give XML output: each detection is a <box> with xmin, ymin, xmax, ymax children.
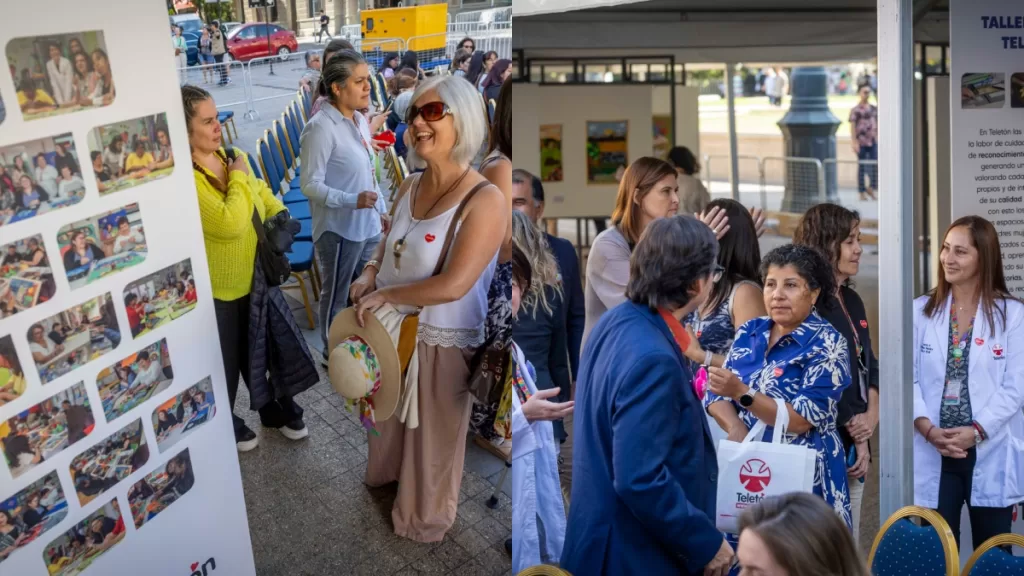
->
<box><xmin>328</xmin><ymin>307</ymin><xmax>401</xmax><ymax>422</ymax></box>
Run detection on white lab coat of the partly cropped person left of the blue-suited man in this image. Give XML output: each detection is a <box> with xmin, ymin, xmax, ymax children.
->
<box><xmin>512</xmin><ymin>344</ymin><xmax>565</xmax><ymax>574</ymax></box>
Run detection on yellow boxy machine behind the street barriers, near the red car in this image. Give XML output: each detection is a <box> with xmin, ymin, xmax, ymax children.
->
<box><xmin>359</xmin><ymin>3</ymin><xmax>447</xmax><ymax>53</ymax></box>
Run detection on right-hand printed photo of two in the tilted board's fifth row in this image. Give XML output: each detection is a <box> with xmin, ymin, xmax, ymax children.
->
<box><xmin>96</xmin><ymin>338</ymin><xmax>174</xmax><ymax>422</ymax></box>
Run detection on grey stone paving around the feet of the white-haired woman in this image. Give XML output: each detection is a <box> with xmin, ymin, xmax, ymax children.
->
<box><xmin>238</xmin><ymin>353</ymin><xmax>512</xmax><ymax>576</ymax></box>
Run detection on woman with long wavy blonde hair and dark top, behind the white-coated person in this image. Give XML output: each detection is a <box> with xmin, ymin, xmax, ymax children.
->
<box><xmin>512</xmin><ymin>210</ymin><xmax>572</xmax><ymax>443</ymax></box>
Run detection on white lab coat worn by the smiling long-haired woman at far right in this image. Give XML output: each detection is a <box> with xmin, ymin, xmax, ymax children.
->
<box><xmin>913</xmin><ymin>296</ymin><xmax>1024</xmax><ymax>508</ymax></box>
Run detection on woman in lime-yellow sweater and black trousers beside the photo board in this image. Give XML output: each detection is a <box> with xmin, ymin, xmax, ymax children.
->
<box><xmin>181</xmin><ymin>85</ymin><xmax>308</xmax><ymax>452</ymax></box>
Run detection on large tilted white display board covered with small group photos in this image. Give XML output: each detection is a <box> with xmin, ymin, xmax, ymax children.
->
<box><xmin>0</xmin><ymin>0</ymin><xmax>255</xmax><ymax>576</ymax></box>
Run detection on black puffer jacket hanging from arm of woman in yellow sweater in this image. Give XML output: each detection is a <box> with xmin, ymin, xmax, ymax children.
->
<box><xmin>249</xmin><ymin>256</ymin><xmax>319</xmax><ymax>410</ymax></box>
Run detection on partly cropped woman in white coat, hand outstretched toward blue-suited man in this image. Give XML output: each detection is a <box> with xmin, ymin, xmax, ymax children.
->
<box><xmin>512</xmin><ymin>239</ymin><xmax>573</xmax><ymax>574</ymax></box>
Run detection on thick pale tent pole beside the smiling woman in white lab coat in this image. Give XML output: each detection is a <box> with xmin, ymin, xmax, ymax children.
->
<box><xmin>878</xmin><ymin>0</ymin><xmax>915</xmax><ymax>522</ymax></box>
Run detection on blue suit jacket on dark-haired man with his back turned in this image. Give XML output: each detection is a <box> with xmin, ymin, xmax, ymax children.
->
<box><xmin>560</xmin><ymin>302</ymin><xmax>724</xmax><ymax>576</ymax></box>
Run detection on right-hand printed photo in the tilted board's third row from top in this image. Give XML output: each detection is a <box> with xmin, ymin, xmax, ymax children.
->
<box><xmin>57</xmin><ymin>204</ymin><xmax>148</xmax><ymax>290</ymax></box>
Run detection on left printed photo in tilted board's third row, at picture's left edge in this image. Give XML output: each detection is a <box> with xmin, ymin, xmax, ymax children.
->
<box><xmin>0</xmin><ymin>234</ymin><xmax>57</xmax><ymax>320</ymax></box>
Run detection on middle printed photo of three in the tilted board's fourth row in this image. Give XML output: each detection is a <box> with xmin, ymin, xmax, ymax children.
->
<box><xmin>28</xmin><ymin>293</ymin><xmax>121</xmax><ymax>384</ymax></box>
